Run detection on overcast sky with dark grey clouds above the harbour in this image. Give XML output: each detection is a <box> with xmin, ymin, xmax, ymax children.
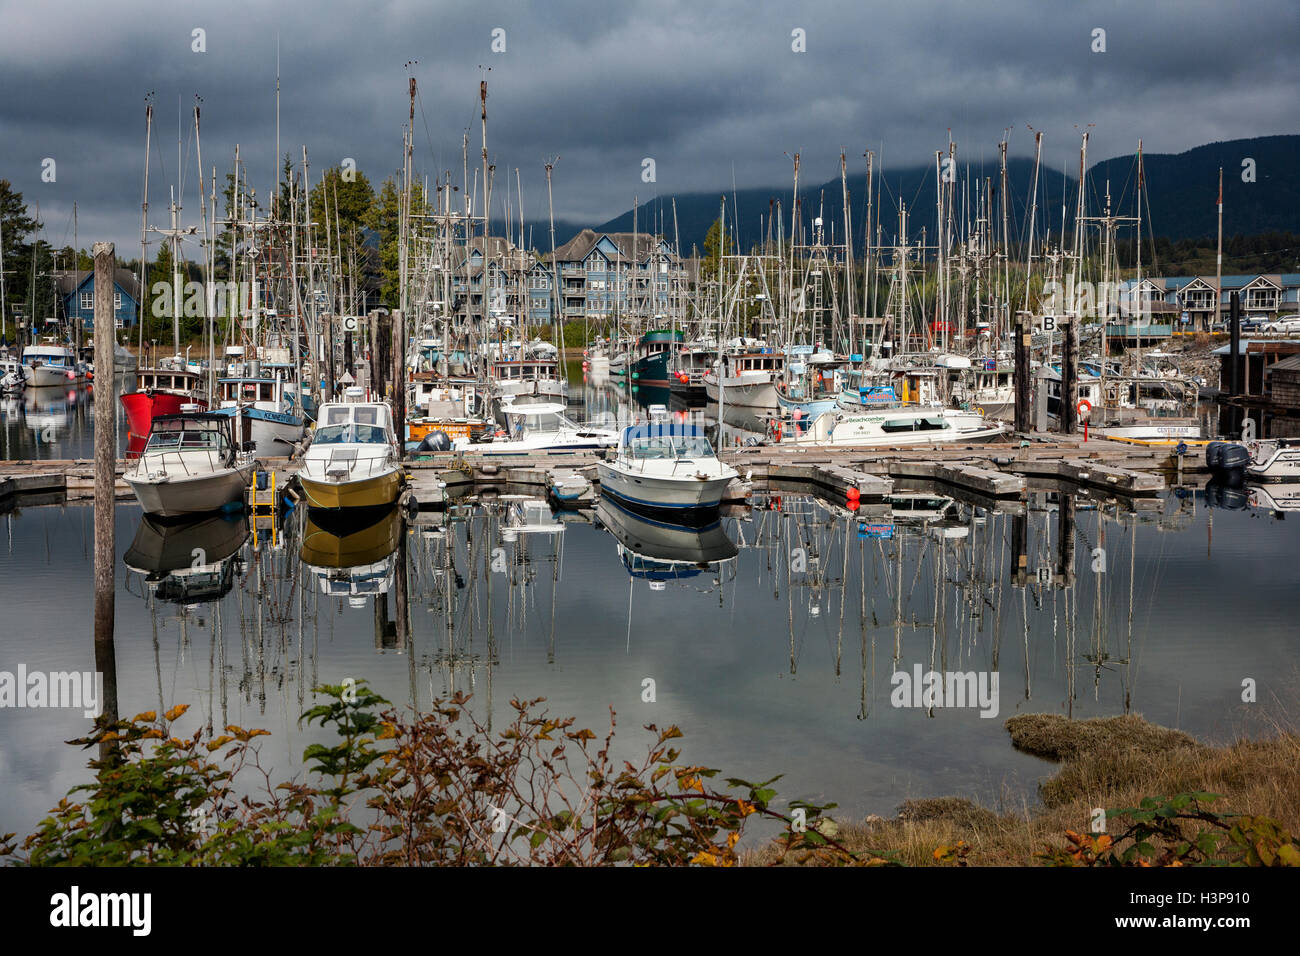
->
<box><xmin>0</xmin><ymin>0</ymin><xmax>1300</xmax><ymax>256</ymax></box>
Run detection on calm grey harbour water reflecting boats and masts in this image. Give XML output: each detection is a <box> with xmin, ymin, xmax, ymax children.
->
<box><xmin>0</xmin><ymin>369</ymin><xmax>1300</xmax><ymax>832</ymax></box>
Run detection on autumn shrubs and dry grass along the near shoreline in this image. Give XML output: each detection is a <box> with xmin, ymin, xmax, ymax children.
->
<box><xmin>0</xmin><ymin>680</ymin><xmax>1300</xmax><ymax>866</ymax></box>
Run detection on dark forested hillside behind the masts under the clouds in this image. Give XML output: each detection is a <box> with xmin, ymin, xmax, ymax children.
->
<box><xmin>582</xmin><ymin>135</ymin><xmax>1300</xmax><ymax>255</ymax></box>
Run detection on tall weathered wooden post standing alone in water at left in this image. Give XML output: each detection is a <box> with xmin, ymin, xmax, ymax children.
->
<box><xmin>94</xmin><ymin>242</ymin><xmax>117</xmax><ymax>738</ymax></box>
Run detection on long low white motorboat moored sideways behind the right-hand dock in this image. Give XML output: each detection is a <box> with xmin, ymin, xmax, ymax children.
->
<box><xmin>779</xmin><ymin>406</ymin><xmax>1011</xmax><ymax>446</ymax></box>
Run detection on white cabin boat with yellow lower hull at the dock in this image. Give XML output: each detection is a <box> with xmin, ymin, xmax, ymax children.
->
<box><xmin>298</xmin><ymin>398</ymin><xmax>403</xmax><ymax>511</ymax></box>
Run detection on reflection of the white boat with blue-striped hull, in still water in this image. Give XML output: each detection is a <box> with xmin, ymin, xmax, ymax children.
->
<box><xmin>595</xmin><ymin>498</ymin><xmax>740</xmax><ymax>591</ymax></box>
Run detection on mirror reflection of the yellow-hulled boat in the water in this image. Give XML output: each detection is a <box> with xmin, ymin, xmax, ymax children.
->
<box><xmin>298</xmin><ymin>505</ymin><xmax>402</xmax><ymax>607</ymax></box>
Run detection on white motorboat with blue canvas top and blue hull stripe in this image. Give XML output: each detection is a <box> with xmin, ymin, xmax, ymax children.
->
<box><xmin>597</xmin><ymin>423</ymin><xmax>737</xmax><ymax>520</ymax></box>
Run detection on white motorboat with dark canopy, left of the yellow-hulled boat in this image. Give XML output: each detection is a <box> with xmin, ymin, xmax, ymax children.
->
<box><xmin>125</xmin><ymin>412</ymin><xmax>255</xmax><ymax>518</ymax></box>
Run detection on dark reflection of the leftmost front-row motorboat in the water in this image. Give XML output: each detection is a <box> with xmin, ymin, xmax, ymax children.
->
<box><xmin>124</xmin><ymin>514</ymin><xmax>248</xmax><ymax>604</ymax></box>
